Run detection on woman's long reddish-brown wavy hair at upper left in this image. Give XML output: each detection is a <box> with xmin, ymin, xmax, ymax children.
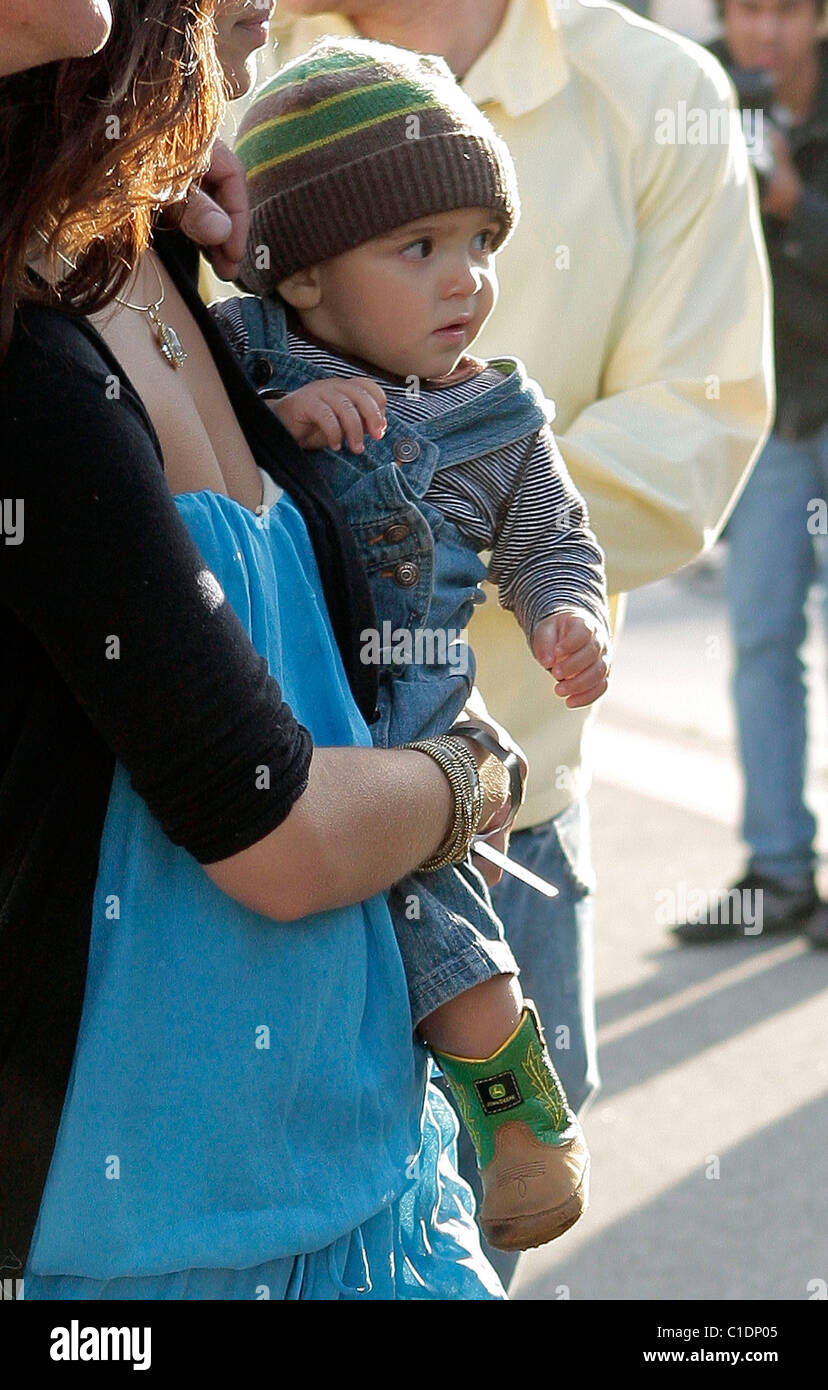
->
<box><xmin>0</xmin><ymin>0</ymin><xmax>225</xmax><ymax>347</ymax></box>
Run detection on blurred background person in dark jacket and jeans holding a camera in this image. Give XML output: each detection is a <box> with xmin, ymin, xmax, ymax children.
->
<box><xmin>674</xmin><ymin>0</ymin><xmax>828</xmax><ymax>947</ymax></box>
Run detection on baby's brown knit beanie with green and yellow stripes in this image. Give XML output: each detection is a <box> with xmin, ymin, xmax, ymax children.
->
<box><xmin>236</xmin><ymin>38</ymin><xmax>520</xmax><ymax>295</ymax></box>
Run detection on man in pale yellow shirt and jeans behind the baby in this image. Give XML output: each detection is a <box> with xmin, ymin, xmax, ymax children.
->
<box><xmin>275</xmin><ymin>0</ymin><xmax>772</xmax><ymax>1276</ymax></box>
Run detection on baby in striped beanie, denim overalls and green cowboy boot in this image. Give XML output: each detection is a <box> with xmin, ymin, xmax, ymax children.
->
<box><xmin>214</xmin><ymin>39</ymin><xmax>610</xmax><ymax>1250</ymax></box>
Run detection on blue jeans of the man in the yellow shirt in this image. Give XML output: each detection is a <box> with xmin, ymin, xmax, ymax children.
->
<box><xmin>439</xmin><ymin>801</ymin><xmax>599</xmax><ymax>1289</ymax></box>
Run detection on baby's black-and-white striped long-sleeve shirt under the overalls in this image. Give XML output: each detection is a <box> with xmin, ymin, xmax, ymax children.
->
<box><xmin>213</xmin><ymin>299</ymin><xmax>610</xmax><ymax>642</ymax></box>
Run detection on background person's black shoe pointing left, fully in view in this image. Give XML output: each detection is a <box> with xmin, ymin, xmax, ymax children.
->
<box><xmin>671</xmin><ymin>872</ymin><xmax>828</xmax><ymax>945</ymax></box>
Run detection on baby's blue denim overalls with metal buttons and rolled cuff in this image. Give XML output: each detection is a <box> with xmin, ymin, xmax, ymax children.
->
<box><xmin>229</xmin><ymin>296</ymin><xmax>549</xmax><ymax>1024</ymax></box>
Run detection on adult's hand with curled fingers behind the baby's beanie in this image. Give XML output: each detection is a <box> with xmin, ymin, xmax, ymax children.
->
<box><xmin>167</xmin><ymin>140</ymin><xmax>250</xmax><ymax>279</ymax></box>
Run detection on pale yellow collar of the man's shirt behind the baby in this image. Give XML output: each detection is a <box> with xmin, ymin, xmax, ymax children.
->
<box><xmin>463</xmin><ymin>0</ymin><xmax>579</xmax><ymax>117</ymax></box>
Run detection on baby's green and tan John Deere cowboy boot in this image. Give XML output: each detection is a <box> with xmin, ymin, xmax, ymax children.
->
<box><xmin>432</xmin><ymin>999</ymin><xmax>589</xmax><ymax>1250</ymax></box>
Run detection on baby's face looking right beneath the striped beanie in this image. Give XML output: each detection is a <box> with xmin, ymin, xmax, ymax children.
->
<box><xmin>303</xmin><ymin>207</ymin><xmax>500</xmax><ymax>378</ymax></box>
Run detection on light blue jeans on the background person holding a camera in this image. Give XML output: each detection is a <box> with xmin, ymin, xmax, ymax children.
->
<box><xmin>725</xmin><ymin>425</ymin><xmax>828</xmax><ymax>878</ymax></box>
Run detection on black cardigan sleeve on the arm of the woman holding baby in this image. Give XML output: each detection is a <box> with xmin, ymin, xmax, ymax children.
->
<box><xmin>0</xmin><ymin>306</ymin><xmax>311</xmax><ymax>863</ymax></box>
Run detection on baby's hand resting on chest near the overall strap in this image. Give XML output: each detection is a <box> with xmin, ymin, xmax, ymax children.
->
<box><xmin>268</xmin><ymin>377</ymin><xmax>388</xmax><ymax>453</ymax></box>
